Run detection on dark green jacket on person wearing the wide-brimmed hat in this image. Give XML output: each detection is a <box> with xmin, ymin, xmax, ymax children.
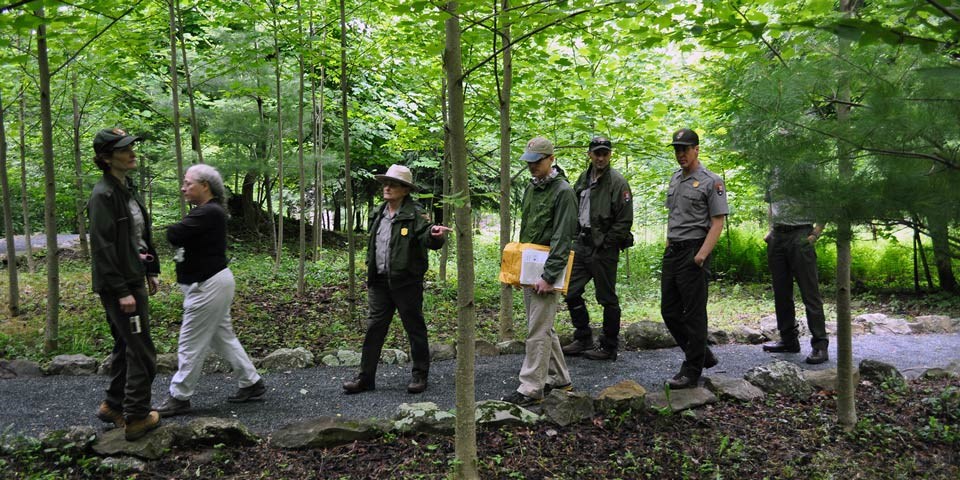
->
<box><xmin>367</xmin><ymin>196</ymin><xmax>444</xmax><ymax>288</ymax></box>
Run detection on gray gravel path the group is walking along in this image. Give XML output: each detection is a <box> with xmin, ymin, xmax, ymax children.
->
<box><xmin>0</xmin><ymin>334</ymin><xmax>960</xmax><ymax>436</ymax></box>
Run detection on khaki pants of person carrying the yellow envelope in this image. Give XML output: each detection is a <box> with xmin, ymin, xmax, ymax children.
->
<box><xmin>517</xmin><ymin>287</ymin><xmax>570</xmax><ymax>398</ymax></box>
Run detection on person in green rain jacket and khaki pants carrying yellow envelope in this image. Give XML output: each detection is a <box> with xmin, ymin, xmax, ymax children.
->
<box><xmin>503</xmin><ymin>137</ymin><xmax>577</xmax><ymax>406</ymax></box>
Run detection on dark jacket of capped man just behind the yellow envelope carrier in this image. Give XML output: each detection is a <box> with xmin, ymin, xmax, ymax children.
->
<box><xmin>573</xmin><ymin>165</ymin><xmax>633</xmax><ymax>250</ymax></box>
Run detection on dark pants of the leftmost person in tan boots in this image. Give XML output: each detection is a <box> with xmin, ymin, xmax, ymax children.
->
<box><xmin>100</xmin><ymin>285</ymin><xmax>157</xmax><ymax>419</ymax></box>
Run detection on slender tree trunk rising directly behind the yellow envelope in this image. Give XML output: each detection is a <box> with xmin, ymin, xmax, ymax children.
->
<box><xmin>493</xmin><ymin>0</ymin><xmax>516</xmax><ymax>341</ymax></box>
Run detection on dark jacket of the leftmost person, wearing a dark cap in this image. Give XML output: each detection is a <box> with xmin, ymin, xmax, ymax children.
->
<box><xmin>87</xmin><ymin>173</ymin><xmax>160</xmax><ymax>297</ymax></box>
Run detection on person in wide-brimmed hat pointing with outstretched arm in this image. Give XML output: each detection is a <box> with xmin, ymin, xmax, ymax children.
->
<box><xmin>343</xmin><ymin>165</ymin><xmax>451</xmax><ymax>394</ymax></box>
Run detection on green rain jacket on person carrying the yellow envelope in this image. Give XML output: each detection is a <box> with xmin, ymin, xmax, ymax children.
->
<box><xmin>520</xmin><ymin>167</ymin><xmax>577</xmax><ymax>285</ymax></box>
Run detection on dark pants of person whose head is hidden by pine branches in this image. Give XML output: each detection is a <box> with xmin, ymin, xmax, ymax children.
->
<box><xmin>767</xmin><ymin>225</ymin><xmax>829</xmax><ymax>349</ymax></box>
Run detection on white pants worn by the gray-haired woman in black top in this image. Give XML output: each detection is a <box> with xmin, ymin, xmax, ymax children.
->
<box><xmin>170</xmin><ymin>268</ymin><xmax>260</xmax><ymax>400</ymax></box>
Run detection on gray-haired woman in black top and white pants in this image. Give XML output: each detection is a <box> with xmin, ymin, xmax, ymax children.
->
<box><xmin>157</xmin><ymin>163</ymin><xmax>267</xmax><ymax>417</ymax></box>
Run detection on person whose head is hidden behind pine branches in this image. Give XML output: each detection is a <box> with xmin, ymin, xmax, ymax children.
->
<box><xmin>763</xmin><ymin>169</ymin><xmax>830</xmax><ymax>364</ymax></box>
